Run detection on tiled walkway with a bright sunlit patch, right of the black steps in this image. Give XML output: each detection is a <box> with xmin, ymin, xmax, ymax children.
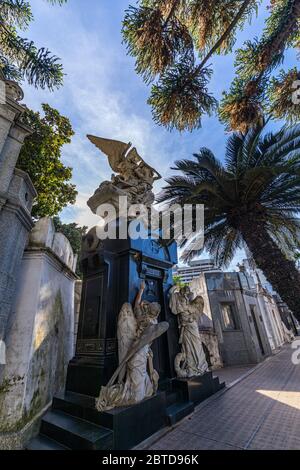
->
<box><xmin>149</xmin><ymin>346</ymin><xmax>300</xmax><ymax>450</ymax></box>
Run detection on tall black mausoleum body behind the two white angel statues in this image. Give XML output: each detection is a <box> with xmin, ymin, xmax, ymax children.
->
<box><xmin>67</xmin><ymin>225</ymin><xmax>178</xmax><ymax>396</ymax></box>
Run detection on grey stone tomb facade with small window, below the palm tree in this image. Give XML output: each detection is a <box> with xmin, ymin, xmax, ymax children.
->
<box><xmin>191</xmin><ymin>271</ymin><xmax>271</xmax><ymax>365</ymax></box>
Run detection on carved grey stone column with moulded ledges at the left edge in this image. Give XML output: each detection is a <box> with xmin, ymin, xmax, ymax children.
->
<box><xmin>0</xmin><ymin>81</ymin><xmax>36</xmax><ymax>366</ymax></box>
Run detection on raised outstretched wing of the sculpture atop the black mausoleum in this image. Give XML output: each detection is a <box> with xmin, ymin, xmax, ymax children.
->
<box><xmin>87</xmin><ymin>135</ymin><xmax>131</xmax><ymax>173</ymax></box>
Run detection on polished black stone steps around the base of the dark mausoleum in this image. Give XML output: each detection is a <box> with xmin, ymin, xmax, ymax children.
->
<box><xmin>27</xmin><ymin>372</ymin><xmax>225</xmax><ymax>450</ymax></box>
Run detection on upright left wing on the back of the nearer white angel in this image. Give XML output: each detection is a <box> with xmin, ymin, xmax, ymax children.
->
<box><xmin>117</xmin><ymin>303</ymin><xmax>137</xmax><ymax>382</ymax></box>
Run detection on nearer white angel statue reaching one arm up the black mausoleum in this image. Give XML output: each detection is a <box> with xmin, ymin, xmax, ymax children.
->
<box><xmin>96</xmin><ymin>282</ymin><xmax>169</xmax><ymax>411</ymax></box>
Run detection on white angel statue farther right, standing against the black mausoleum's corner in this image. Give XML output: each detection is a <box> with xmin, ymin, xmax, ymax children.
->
<box><xmin>169</xmin><ymin>286</ymin><xmax>208</xmax><ymax>378</ymax></box>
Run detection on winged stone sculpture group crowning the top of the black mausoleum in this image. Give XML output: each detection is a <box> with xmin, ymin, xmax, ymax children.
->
<box><xmin>87</xmin><ymin>135</ymin><xmax>161</xmax><ymax>213</ymax></box>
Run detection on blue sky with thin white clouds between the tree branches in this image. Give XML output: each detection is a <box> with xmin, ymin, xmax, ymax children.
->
<box><xmin>23</xmin><ymin>0</ymin><xmax>296</xmax><ymax>266</ymax></box>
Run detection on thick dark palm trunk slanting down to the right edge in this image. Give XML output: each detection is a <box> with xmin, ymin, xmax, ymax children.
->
<box><xmin>241</xmin><ymin>222</ymin><xmax>300</xmax><ymax>321</ymax></box>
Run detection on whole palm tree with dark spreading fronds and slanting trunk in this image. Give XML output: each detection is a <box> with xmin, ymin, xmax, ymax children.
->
<box><xmin>158</xmin><ymin>124</ymin><xmax>300</xmax><ymax>320</ymax></box>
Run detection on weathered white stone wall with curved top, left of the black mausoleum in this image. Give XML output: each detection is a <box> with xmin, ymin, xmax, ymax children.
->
<box><xmin>0</xmin><ymin>218</ymin><xmax>76</xmax><ymax>446</ymax></box>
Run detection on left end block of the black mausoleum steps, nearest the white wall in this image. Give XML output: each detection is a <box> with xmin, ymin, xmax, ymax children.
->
<box><xmin>41</xmin><ymin>409</ymin><xmax>113</xmax><ymax>450</ymax></box>
